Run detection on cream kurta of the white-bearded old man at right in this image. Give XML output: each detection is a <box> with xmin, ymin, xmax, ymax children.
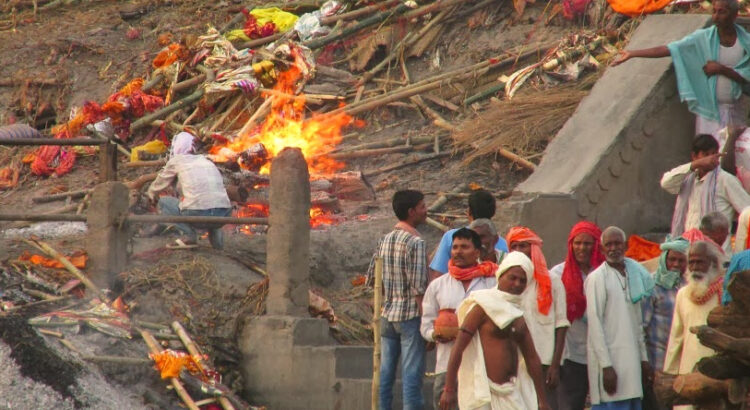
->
<box><xmin>664</xmin><ymin>288</ymin><xmax>719</xmax><ymax>374</ymax></box>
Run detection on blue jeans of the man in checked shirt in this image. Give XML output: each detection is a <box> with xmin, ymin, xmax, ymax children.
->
<box><xmin>380</xmin><ymin>317</ymin><xmax>425</xmax><ymax>410</ymax></box>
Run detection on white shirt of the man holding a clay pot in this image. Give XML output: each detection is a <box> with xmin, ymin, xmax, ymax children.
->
<box><xmin>419</xmin><ymin>273</ymin><xmax>497</xmax><ymax>373</ymax></box>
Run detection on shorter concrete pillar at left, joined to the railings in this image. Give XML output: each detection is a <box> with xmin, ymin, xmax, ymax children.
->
<box><xmin>86</xmin><ymin>182</ymin><xmax>130</xmax><ymax>289</ymax></box>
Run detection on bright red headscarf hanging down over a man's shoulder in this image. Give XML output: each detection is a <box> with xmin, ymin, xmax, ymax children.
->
<box><xmin>562</xmin><ymin>221</ymin><xmax>604</xmax><ymax>322</ymax></box>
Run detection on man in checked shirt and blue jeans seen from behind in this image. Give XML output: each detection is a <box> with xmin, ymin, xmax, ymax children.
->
<box><xmin>367</xmin><ymin>190</ymin><xmax>427</xmax><ymax>409</ymax></box>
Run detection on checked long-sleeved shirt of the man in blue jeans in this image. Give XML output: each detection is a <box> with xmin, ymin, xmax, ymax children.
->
<box><xmin>367</xmin><ymin>229</ymin><xmax>427</xmax><ymax>322</ymax></box>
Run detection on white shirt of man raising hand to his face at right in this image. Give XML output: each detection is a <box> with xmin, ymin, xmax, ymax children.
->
<box><xmin>661</xmin><ymin>163</ymin><xmax>750</xmax><ymax>231</ymax></box>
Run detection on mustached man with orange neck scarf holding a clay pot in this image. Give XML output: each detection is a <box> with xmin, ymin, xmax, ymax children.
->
<box><xmin>420</xmin><ymin>228</ymin><xmax>497</xmax><ymax>409</ymax></box>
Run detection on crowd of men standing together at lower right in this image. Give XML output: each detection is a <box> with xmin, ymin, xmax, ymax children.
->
<box><xmin>368</xmin><ymin>190</ymin><xmax>750</xmax><ymax>410</ymax></box>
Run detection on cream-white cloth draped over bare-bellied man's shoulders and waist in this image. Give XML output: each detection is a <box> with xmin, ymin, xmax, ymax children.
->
<box><xmin>456</xmin><ymin>288</ymin><xmax>537</xmax><ymax>410</ymax></box>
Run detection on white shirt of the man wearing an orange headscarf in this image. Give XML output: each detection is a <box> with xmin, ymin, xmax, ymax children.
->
<box><xmin>521</xmin><ymin>273</ymin><xmax>570</xmax><ymax>366</ymax></box>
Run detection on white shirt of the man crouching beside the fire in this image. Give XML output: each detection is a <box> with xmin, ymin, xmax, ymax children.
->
<box><xmin>148</xmin><ymin>154</ymin><xmax>232</xmax><ymax>209</ymax></box>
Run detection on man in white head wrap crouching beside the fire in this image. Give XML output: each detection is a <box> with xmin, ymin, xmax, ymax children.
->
<box><xmin>146</xmin><ymin>132</ymin><xmax>232</xmax><ymax>249</ymax></box>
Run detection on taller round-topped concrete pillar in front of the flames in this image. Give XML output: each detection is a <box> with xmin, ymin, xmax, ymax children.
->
<box><xmin>266</xmin><ymin>148</ymin><xmax>310</xmax><ymax>316</ymax></box>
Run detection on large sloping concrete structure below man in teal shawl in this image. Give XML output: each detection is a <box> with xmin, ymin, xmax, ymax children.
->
<box><xmin>509</xmin><ymin>15</ymin><xmax>709</xmax><ymax>265</ymax></box>
